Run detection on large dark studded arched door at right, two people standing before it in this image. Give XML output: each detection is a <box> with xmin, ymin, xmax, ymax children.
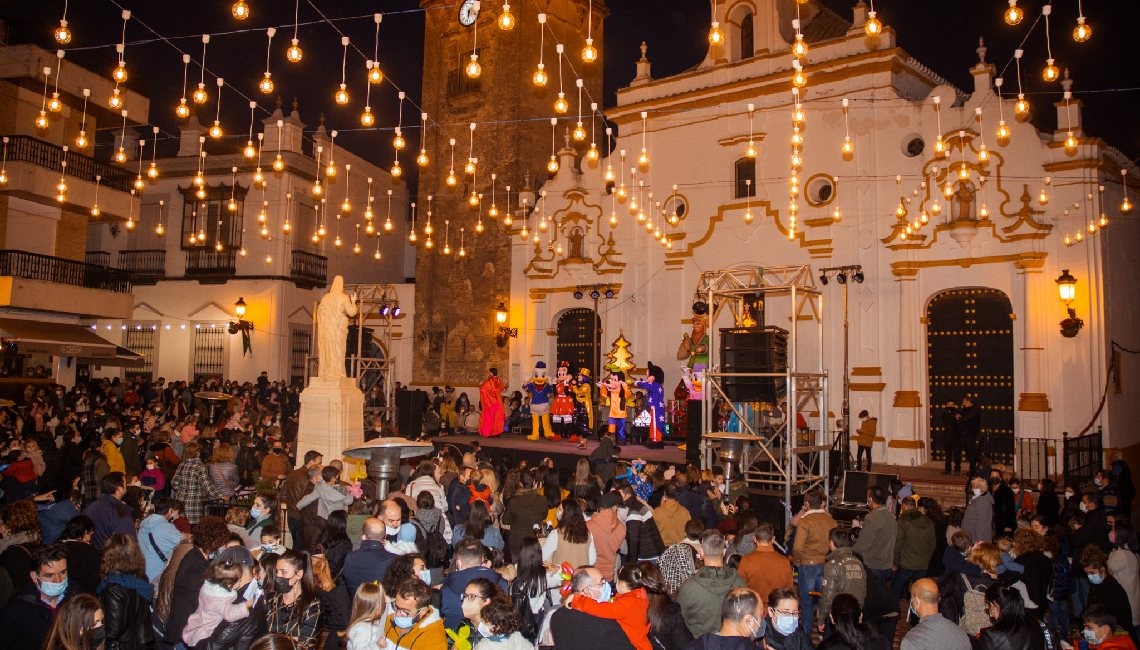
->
<box><xmin>927</xmin><ymin>287</ymin><xmax>1013</xmax><ymax>466</ymax></box>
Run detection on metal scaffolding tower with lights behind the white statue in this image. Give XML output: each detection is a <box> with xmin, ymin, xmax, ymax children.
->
<box><xmin>304</xmin><ymin>284</ymin><xmax>400</xmax><ymax>426</ymax></box>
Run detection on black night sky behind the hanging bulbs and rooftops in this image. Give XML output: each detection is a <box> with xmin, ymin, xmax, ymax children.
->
<box><xmin>0</xmin><ymin>0</ymin><xmax>1140</xmax><ymax>189</ymax></box>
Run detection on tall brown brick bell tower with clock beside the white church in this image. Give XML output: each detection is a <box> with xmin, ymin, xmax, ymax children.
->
<box><xmin>413</xmin><ymin>0</ymin><xmax>609</xmax><ymax>385</ymax></box>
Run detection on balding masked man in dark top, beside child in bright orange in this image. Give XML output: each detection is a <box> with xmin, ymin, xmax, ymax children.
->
<box><xmin>549</xmin><ymin>566</ymin><xmax>633</xmax><ymax>650</ymax></box>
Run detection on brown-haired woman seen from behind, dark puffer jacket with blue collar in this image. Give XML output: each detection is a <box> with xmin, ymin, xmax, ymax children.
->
<box><xmin>96</xmin><ymin>533</ymin><xmax>154</xmax><ymax>650</ymax></box>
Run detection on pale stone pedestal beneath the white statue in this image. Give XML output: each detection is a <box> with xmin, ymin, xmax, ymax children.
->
<box><xmin>296</xmin><ymin>377</ymin><xmax>364</xmax><ymax>470</ymax></box>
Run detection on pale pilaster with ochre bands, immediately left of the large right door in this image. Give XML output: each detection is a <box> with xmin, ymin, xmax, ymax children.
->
<box><xmin>886</xmin><ymin>268</ymin><xmax>926</xmax><ymax>464</ymax></box>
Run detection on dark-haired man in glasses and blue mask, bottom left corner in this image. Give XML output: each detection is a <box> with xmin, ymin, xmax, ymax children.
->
<box><xmin>0</xmin><ymin>544</ymin><xmax>72</xmax><ymax>650</ymax></box>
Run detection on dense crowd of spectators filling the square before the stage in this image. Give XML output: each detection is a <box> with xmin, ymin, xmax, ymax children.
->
<box><xmin>0</xmin><ymin>377</ymin><xmax>1140</xmax><ymax>650</ymax></box>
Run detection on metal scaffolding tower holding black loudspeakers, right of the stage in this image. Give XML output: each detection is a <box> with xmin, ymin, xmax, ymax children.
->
<box><xmin>697</xmin><ymin>265</ymin><xmax>831</xmax><ymax>518</ymax></box>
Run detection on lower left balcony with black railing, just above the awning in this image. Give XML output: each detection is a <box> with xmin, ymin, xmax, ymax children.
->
<box><xmin>0</xmin><ymin>250</ymin><xmax>133</xmax><ymax>318</ymax></box>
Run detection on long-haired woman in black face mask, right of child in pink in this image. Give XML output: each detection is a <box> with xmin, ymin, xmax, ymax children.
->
<box><xmin>266</xmin><ymin>549</ymin><xmax>320</xmax><ymax>648</ymax></box>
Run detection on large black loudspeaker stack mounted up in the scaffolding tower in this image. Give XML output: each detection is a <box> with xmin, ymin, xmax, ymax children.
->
<box><xmin>720</xmin><ymin>327</ymin><xmax>788</xmax><ymax>404</ymax></box>
